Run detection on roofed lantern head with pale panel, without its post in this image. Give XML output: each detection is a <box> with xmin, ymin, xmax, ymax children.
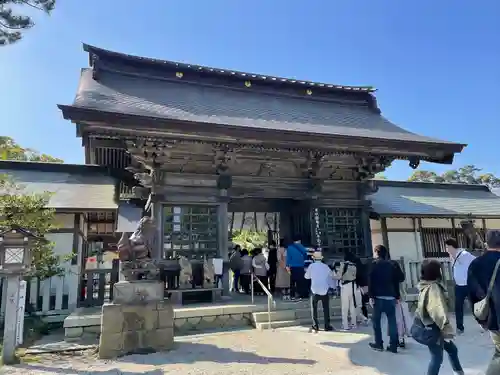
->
<box><xmin>0</xmin><ymin>226</ymin><xmax>38</xmax><ymax>275</ymax></box>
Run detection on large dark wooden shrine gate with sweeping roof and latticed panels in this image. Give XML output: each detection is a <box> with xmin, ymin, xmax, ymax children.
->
<box><xmin>59</xmin><ymin>45</ymin><xmax>464</xmax><ymax>257</ymax></box>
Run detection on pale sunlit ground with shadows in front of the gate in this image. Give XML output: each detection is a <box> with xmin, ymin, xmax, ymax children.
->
<box><xmin>1</xmin><ymin>319</ymin><xmax>492</xmax><ymax>375</ymax></box>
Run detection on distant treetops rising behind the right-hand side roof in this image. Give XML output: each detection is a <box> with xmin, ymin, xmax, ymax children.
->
<box><xmin>408</xmin><ymin>165</ymin><xmax>500</xmax><ymax>188</ymax></box>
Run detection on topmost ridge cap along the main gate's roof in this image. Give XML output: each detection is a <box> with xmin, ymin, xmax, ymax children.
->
<box><xmin>83</xmin><ymin>43</ymin><xmax>377</xmax><ymax>93</ymax></box>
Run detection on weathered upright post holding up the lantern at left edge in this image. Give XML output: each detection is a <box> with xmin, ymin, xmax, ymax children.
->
<box><xmin>2</xmin><ymin>275</ymin><xmax>21</xmax><ymax>364</ymax></box>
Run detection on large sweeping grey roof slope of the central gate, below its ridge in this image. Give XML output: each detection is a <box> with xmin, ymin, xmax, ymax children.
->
<box><xmin>69</xmin><ymin>69</ymin><xmax>463</xmax><ymax>147</ymax></box>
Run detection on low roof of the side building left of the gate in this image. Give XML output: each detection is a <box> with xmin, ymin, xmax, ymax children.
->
<box><xmin>0</xmin><ymin>162</ymin><xmax>117</xmax><ymax>210</ymax></box>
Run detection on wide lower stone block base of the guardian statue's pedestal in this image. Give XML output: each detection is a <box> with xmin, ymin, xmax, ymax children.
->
<box><xmin>99</xmin><ymin>301</ymin><xmax>174</xmax><ymax>359</ymax></box>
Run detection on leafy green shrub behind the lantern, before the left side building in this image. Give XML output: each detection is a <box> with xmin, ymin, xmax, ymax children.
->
<box><xmin>0</xmin><ymin>175</ymin><xmax>65</xmax><ymax>279</ymax></box>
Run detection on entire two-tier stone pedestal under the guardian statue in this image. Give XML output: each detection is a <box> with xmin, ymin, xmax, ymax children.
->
<box><xmin>99</xmin><ymin>281</ymin><xmax>174</xmax><ymax>359</ymax></box>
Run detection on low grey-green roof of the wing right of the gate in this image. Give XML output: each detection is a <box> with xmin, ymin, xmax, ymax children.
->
<box><xmin>368</xmin><ymin>181</ymin><xmax>500</xmax><ymax>217</ymax></box>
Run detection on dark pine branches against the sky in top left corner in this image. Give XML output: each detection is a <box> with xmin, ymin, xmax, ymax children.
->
<box><xmin>0</xmin><ymin>0</ymin><xmax>56</xmax><ymax>46</ymax></box>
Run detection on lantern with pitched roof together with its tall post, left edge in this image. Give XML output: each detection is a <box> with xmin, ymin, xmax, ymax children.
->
<box><xmin>0</xmin><ymin>226</ymin><xmax>39</xmax><ymax>364</ymax></box>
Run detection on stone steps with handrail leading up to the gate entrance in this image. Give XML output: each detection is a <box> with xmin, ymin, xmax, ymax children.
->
<box><xmin>251</xmin><ymin>299</ymin><xmax>341</xmax><ymax>330</ymax></box>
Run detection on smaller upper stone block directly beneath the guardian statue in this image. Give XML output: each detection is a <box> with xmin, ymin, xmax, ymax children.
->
<box><xmin>113</xmin><ymin>280</ymin><xmax>165</xmax><ymax>304</ymax></box>
